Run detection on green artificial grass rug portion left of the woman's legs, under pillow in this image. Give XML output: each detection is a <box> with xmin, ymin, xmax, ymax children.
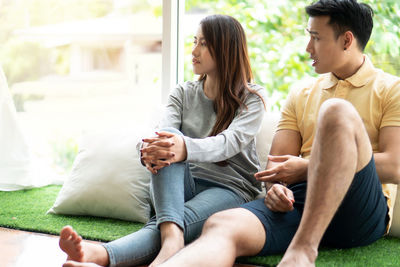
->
<box><xmin>0</xmin><ymin>185</ymin><xmax>143</xmax><ymax>241</ymax></box>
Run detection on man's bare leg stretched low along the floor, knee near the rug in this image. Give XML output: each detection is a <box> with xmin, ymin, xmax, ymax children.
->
<box><xmin>160</xmin><ymin>208</ymin><xmax>265</xmax><ymax>267</ymax></box>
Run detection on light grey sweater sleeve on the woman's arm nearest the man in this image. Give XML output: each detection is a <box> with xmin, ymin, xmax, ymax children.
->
<box><xmin>184</xmin><ymin>89</ymin><xmax>266</xmax><ymax>162</ymax></box>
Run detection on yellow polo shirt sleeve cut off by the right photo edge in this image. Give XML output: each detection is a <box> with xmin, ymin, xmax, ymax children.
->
<box><xmin>380</xmin><ymin>80</ymin><xmax>400</xmax><ymax>128</ymax></box>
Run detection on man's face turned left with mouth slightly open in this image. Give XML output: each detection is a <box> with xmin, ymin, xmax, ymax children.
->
<box><xmin>306</xmin><ymin>16</ymin><xmax>346</xmax><ymax>74</ymax></box>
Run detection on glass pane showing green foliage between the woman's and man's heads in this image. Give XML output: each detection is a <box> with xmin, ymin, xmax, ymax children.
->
<box><xmin>185</xmin><ymin>0</ymin><xmax>312</xmax><ymax>110</ymax></box>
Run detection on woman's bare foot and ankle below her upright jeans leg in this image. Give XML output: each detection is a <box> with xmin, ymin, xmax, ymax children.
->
<box><xmin>149</xmin><ymin>222</ymin><xmax>185</xmax><ymax>267</ymax></box>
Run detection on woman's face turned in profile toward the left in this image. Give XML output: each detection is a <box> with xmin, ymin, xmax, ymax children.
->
<box><xmin>192</xmin><ymin>25</ymin><xmax>216</xmax><ymax>75</ymax></box>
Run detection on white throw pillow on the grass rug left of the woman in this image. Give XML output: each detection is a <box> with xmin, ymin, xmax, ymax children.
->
<box><xmin>48</xmin><ymin>131</ymin><xmax>150</xmax><ymax>223</ymax></box>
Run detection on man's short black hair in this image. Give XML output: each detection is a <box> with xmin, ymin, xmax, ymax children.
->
<box><xmin>306</xmin><ymin>0</ymin><xmax>374</xmax><ymax>51</ymax></box>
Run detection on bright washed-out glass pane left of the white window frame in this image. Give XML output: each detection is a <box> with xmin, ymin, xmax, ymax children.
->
<box><xmin>0</xmin><ymin>0</ymin><xmax>162</xmax><ymax>180</ymax></box>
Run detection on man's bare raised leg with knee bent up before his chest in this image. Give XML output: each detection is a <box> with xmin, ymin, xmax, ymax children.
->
<box><xmin>278</xmin><ymin>99</ymin><xmax>372</xmax><ymax>267</ymax></box>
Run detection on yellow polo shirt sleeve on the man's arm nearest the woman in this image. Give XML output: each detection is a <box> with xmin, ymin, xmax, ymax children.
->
<box><xmin>277</xmin><ymin>87</ymin><xmax>300</xmax><ymax>132</ymax></box>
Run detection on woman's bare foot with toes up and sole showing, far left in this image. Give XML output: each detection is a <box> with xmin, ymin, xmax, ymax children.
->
<box><xmin>59</xmin><ymin>226</ymin><xmax>109</xmax><ymax>266</ymax></box>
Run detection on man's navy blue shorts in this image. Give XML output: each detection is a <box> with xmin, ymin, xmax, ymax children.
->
<box><xmin>242</xmin><ymin>157</ymin><xmax>389</xmax><ymax>256</ymax></box>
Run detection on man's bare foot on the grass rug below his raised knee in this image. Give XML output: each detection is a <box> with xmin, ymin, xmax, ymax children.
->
<box><xmin>277</xmin><ymin>247</ymin><xmax>318</xmax><ymax>267</ymax></box>
